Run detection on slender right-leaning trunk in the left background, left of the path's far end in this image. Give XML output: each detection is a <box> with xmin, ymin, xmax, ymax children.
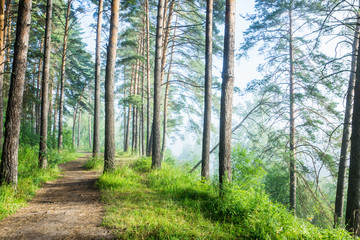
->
<box><xmin>58</xmin><ymin>0</ymin><xmax>73</xmax><ymax>150</ymax></box>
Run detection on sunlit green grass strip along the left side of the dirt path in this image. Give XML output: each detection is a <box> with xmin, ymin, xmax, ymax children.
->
<box><xmin>0</xmin><ymin>147</ymin><xmax>83</xmax><ymax>220</ymax></box>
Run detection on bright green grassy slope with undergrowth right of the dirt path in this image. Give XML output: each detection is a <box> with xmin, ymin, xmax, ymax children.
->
<box><xmin>98</xmin><ymin>159</ymin><xmax>351</xmax><ymax>239</ymax></box>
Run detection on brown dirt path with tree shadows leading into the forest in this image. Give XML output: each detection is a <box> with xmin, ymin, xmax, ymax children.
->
<box><xmin>0</xmin><ymin>157</ymin><xmax>113</xmax><ymax>240</ymax></box>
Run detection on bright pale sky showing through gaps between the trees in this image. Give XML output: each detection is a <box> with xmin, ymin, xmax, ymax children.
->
<box><xmin>81</xmin><ymin>0</ymin><xmax>263</xmax><ymax>156</ymax></box>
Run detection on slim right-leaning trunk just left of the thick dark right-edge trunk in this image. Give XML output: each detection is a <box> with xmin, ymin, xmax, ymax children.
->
<box><xmin>334</xmin><ymin>10</ymin><xmax>360</xmax><ymax>226</ymax></box>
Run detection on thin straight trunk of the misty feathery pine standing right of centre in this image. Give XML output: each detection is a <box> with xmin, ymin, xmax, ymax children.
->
<box><xmin>289</xmin><ymin>3</ymin><xmax>296</xmax><ymax>215</ymax></box>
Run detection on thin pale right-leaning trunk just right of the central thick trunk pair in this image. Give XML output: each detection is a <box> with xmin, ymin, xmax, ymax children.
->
<box><xmin>161</xmin><ymin>17</ymin><xmax>178</xmax><ymax>161</ymax></box>
